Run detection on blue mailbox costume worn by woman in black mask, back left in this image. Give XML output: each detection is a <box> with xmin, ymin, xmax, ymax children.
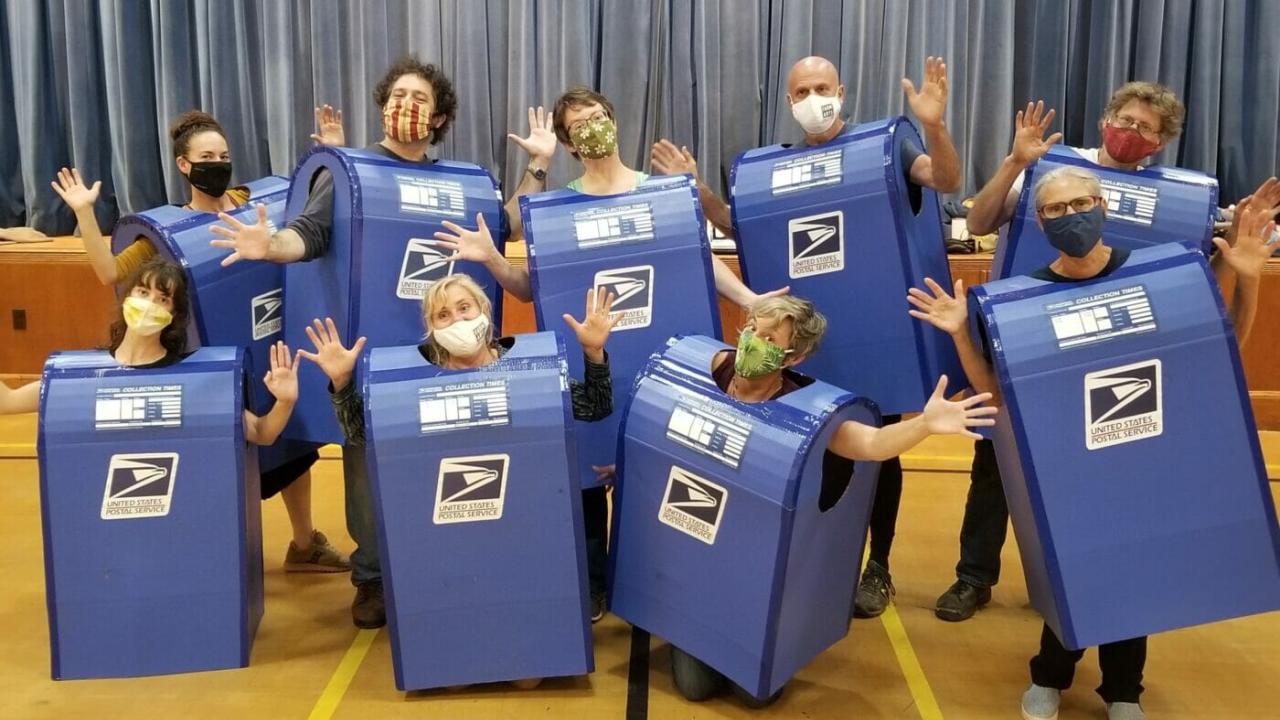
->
<box><xmin>111</xmin><ymin>176</ymin><xmax>315</xmax><ymax>471</ymax></box>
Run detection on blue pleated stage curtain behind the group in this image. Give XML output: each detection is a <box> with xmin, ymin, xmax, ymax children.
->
<box><xmin>0</xmin><ymin>0</ymin><xmax>1280</xmax><ymax>233</ymax></box>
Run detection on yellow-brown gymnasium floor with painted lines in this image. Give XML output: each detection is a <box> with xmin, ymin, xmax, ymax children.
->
<box><xmin>0</xmin><ymin>416</ymin><xmax>1280</xmax><ymax>720</ymax></box>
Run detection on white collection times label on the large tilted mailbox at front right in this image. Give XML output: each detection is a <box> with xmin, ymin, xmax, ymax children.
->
<box><xmin>1044</xmin><ymin>284</ymin><xmax>1156</xmax><ymax>350</ymax></box>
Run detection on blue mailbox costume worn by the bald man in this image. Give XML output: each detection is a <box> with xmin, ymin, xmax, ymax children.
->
<box><xmin>730</xmin><ymin>118</ymin><xmax>963</xmax><ymax>414</ymax></box>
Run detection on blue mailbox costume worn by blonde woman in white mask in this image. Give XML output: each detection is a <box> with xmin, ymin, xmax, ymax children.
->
<box><xmin>364</xmin><ymin>332</ymin><xmax>594</xmax><ymax>691</ymax></box>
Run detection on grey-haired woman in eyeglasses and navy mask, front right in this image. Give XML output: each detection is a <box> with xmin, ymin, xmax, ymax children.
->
<box><xmin>908</xmin><ymin>165</ymin><xmax>1275</xmax><ymax>720</ymax></box>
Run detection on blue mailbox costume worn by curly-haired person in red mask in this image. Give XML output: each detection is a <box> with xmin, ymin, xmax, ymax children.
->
<box><xmin>991</xmin><ymin>146</ymin><xmax>1217</xmax><ymax>278</ymax></box>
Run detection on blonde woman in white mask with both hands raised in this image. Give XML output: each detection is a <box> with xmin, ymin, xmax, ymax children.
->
<box><xmin>301</xmin><ymin>274</ymin><xmax>621</xmax><ymax>688</ymax></box>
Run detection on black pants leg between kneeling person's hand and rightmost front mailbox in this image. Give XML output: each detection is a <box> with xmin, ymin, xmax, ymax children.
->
<box><xmin>956</xmin><ymin>439</ymin><xmax>1009</xmax><ymax>588</ymax></box>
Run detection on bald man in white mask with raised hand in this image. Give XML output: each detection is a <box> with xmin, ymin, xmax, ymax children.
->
<box><xmin>650</xmin><ymin>56</ymin><xmax>960</xmax><ymax>618</ymax></box>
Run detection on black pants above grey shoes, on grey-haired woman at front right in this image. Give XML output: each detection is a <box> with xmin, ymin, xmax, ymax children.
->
<box><xmin>1032</xmin><ymin>625</ymin><xmax>1147</xmax><ymax>702</ymax></box>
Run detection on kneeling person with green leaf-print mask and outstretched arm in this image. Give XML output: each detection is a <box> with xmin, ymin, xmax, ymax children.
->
<box><xmin>671</xmin><ymin>296</ymin><xmax>997</xmax><ymax>707</ymax></box>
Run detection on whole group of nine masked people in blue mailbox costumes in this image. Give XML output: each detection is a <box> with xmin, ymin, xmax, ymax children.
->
<box><xmin>0</xmin><ymin>51</ymin><xmax>1280</xmax><ymax>719</ymax></box>
